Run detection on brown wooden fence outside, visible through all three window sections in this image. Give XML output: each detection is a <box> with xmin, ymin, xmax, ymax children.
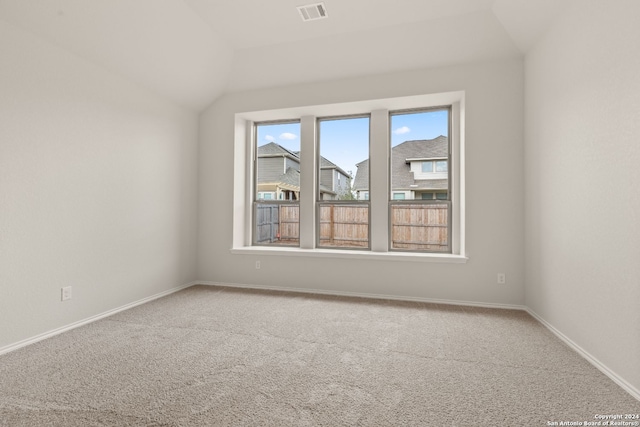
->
<box><xmin>256</xmin><ymin>203</ymin><xmax>449</xmax><ymax>252</ymax></box>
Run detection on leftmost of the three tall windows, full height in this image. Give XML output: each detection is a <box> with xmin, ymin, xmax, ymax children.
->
<box><xmin>253</xmin><ymin>121</ymin><xmax>300</xmax><ymax>246</ymax></box>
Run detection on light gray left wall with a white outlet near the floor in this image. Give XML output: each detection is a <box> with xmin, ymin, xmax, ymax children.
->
<box><xmin>0</xmin><ymin>20</ymin><xmax>200</xmax><ymax>349</ymax></box>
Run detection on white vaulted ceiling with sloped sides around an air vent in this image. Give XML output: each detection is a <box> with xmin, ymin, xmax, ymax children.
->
<box><xmin>0</xmin><ymin>0</ymin><xmax>572</xmax><ymax>110</ymax></box>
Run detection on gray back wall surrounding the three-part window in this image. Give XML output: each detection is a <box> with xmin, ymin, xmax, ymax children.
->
<box><xmin>198</xmin><ymin>60</ymin><xmax>524</xmax><ymax>305</ymax></box>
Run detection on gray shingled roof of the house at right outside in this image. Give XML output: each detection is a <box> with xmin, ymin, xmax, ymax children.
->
<box><xmin>353</xmin><ymin>135</ymin><xmax>449</xmax><ymax>190</ymax></box>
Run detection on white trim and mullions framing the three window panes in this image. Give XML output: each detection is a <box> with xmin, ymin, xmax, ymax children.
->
<box><xmin>231</xmin><ymin>92</ymin><xmax>468</xmax><ymax>263</ymax></box>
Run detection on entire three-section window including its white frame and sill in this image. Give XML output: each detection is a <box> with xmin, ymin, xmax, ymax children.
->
<box><xmin>231</xmin><ymin>92</ymin><xmax>466</xmax><ymax>262</ymax></box>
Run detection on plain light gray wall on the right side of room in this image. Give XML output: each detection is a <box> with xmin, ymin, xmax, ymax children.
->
<box><xmin>525</xmin><ymin>0</ymin><xmax>640</xmax><ymax>390</ymax></box>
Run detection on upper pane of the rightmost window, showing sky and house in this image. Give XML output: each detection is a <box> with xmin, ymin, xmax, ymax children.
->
<box><xmin>391</xmin><ymin>109</ymin><xmax>449</xmax><ymax>200</ymax></box>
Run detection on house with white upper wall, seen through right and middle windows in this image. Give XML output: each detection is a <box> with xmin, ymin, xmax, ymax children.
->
<box><xmin>353</xmin><ymin>136</ymin><xmax>449</xmax><ymax>200</ymax></box>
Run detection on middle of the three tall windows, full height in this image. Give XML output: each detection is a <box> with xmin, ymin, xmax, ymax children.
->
<box><xmin>316</xmin><ymin>116</ymin><xmax>370</xmax><ymax>249</ymax></box>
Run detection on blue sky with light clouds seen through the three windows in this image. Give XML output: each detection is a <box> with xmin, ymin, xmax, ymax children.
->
<box><xmin>257</xmin><ymin>110</ymin><xmax>449</xmax><ymax>176</ymax></box>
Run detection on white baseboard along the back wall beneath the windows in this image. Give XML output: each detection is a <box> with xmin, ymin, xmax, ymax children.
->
<box><xmin>196</xmin><ymin>280</ymin><xmax>527</xmax><ymax>311</ymax></box>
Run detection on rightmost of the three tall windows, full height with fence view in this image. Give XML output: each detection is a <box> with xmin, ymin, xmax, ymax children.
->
<box><xmin>389</xmin><ymin>108</ymin><xmax>451</xmax><ymax>252</ymax></box>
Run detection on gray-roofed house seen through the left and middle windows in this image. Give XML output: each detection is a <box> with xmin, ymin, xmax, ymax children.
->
<box><xmin>257</xmin><ymin>142</ymin><xmax>351</xmax><ymax>200</ymax></box>
